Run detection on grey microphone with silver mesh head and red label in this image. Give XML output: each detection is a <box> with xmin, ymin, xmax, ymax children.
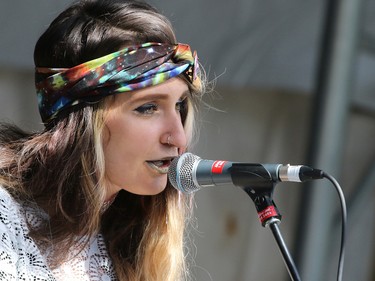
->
<box><xmin>168</xmin><ymin>153</ymin><xmax>323</xmax><ymax>193</ymax></box>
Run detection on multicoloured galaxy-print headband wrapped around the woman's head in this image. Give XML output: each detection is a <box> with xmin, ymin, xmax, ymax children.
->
<box><xmin>36</xmin><ymin>43</ymin><xmax>198</xmax><ymax>123</ymax></box>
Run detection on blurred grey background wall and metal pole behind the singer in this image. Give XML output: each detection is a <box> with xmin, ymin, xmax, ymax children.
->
<box><xmin>0</xmin><ymin>0</ymin><xmax>375</xmax><ymax>281</ymax></box>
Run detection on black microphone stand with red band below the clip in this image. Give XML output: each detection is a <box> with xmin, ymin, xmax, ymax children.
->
<box><xmin>243</xmin><ymin>184</ymin><xmax>301</xmax><ymax>281</ymax></box>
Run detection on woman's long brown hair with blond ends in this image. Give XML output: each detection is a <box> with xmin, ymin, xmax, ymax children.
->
<box><xmin>0</xmin><ymin>0</ymin><xmax>203</xmax><ymax>281</ymax></box>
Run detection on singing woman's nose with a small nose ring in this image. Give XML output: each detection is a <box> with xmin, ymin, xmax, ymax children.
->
<box><xmin>161</xmin><ymin>112</ymin><xmax>187</xmax><ymax>149</ymax></box>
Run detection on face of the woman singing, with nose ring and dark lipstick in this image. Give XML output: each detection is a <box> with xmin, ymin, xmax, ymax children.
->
<box><xmin>103</xmin><ymin>78</ymin><xmax>189</xmax><ymax>198</ymax></box>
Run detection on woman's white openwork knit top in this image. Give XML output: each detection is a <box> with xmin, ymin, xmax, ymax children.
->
<box><xmin>0</xmin><ymin>187</ymin><xmax>116</xmax><ymax>281</ymax></box>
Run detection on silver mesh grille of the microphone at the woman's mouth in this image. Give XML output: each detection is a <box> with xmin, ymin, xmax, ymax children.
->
<box><xmin>168</xmin><ymin>153</ymin><xmax>201</xmax><ymax>193</ymax></box>
